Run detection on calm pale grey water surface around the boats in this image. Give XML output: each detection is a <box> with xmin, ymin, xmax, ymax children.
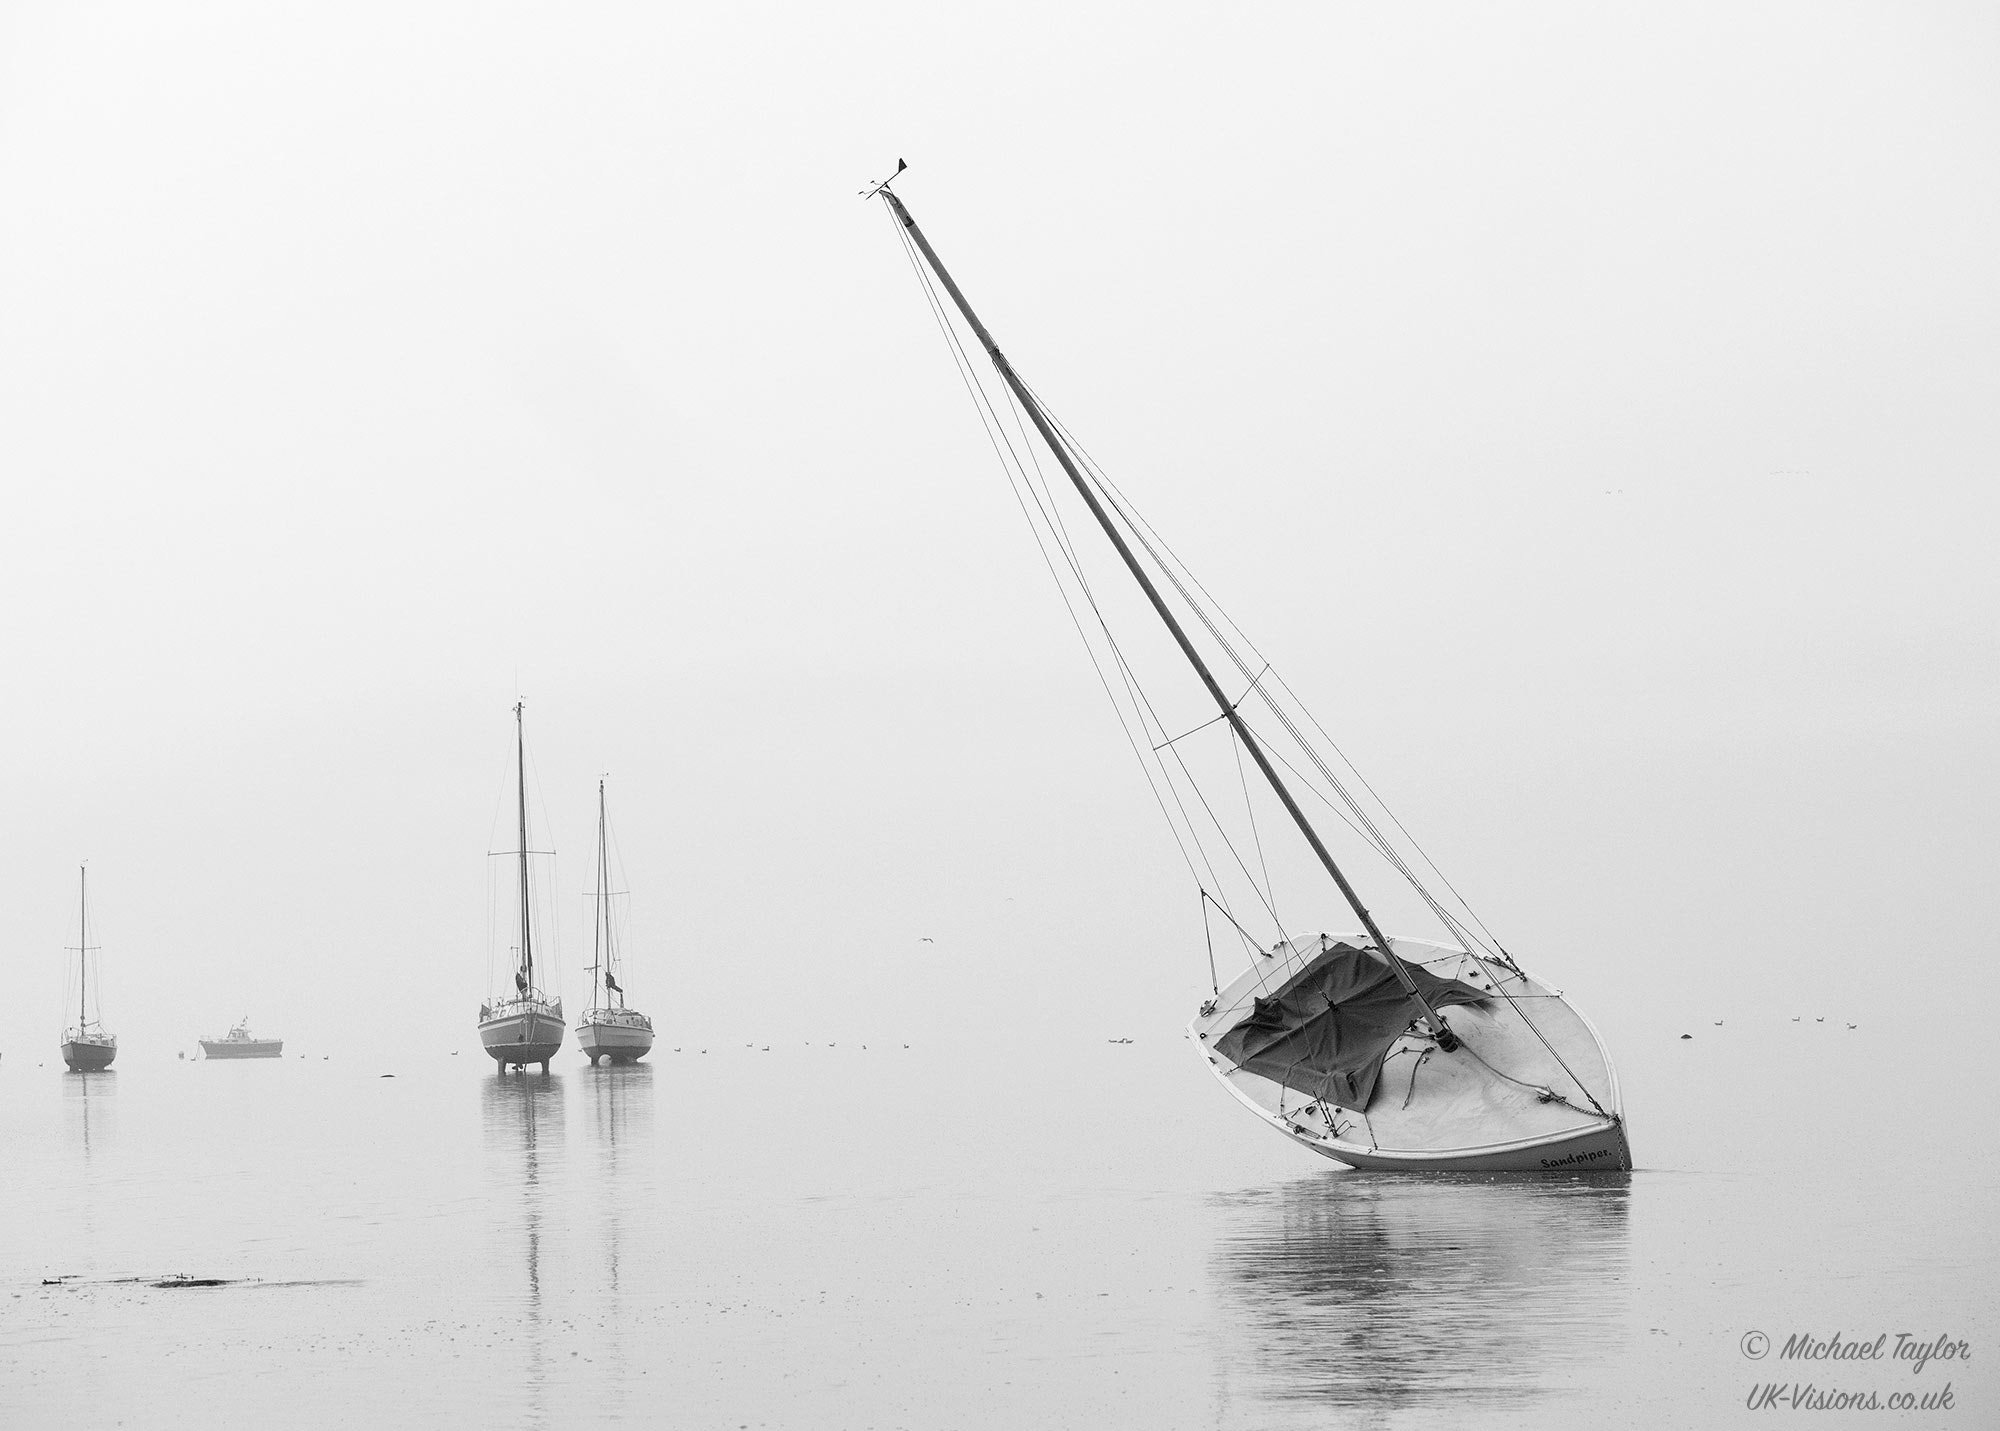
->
<box><xmin>0</xmin><ymin>1019</ymin><xmax>2000</xmax><ymax>1429</ymax></box>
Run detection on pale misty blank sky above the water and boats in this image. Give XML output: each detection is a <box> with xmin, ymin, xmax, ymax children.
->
<box><xmin>0</xmin><ymin>0</ymin><xmax>2000</xmax><ymax>1063</ymax></box>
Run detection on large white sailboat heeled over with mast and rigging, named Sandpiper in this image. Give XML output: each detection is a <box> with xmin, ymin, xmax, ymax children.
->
<box><xmin>864</xmin><ymin>172</ymin><xmax>1632</xmax><ymax>1173</ymax></box>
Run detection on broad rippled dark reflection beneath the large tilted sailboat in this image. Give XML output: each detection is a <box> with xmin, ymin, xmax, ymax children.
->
<box><xmin>1214</xmin><ymin>1173</ymin><xmax>1632</xmax><ymax>1425</ymax></box>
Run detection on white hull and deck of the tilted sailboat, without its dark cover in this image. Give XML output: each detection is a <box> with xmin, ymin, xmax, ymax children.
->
<box><xmin>1188</xmin><ymin>935</ymin><xmax>1632</xmax><ymax>1173</ymax></box>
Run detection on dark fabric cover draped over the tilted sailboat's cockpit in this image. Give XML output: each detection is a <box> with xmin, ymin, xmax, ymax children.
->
<box><xmin>1214</xmin><ymin>943</ymin><xmax>1490</xmax><ymax>1109</ymax></box>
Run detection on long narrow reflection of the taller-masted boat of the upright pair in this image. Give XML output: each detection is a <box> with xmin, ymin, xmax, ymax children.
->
<box><xmin>480</xmin><ymin>1073</ymin><xmax>562</xmax><ymax>1427</ymax></box>
